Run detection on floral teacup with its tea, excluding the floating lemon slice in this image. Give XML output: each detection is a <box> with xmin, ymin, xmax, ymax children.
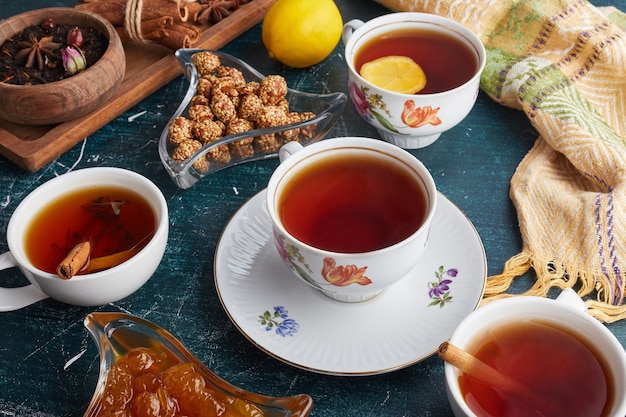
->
<box><xmin>342</xmin><ymin>12</ymin><xmax>486</xmax><ymax>149</ymax></box>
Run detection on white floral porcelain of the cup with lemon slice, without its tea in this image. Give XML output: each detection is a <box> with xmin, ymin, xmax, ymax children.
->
<box><xmin>342</xmin><ymin>12</ymin><xmax>487</xmax><ymax>149</ymax></box>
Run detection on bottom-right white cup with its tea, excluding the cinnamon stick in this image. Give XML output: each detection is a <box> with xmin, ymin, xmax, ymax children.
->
<box><xmin>444</xmin><ymin>288</ymin><xmax>626</xmax><ymax>417</ymax></box>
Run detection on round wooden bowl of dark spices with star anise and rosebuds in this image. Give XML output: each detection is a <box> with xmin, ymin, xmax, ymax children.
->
<box><xmin>0</xmin><ymin>7</ymin><xmax>126</xmax><ymax>125</ymax></box>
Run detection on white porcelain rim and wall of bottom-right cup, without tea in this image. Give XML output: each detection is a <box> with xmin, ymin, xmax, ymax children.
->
<box><xmin>444</xmin><ymin>288</ymin><xmax>626</xmax><ymax>417</ymax></box>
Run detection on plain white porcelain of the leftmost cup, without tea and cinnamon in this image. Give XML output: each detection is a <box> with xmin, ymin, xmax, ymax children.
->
<box><xmin>0</xmin><ymin>167</ymin><xmax>169</xmax><ymax>311</ymax></box>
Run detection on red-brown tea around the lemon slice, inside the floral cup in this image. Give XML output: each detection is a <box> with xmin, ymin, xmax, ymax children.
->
<box><xmin>354</xmin><ymin>28</ymin><xmax>478</xmax><ymax>94</ymax></box>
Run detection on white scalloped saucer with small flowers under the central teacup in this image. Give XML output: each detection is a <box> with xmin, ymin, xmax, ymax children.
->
<box><xmin>215</xmin><ymin>191</ymin><xmax>487</xmax><ymax>375</ymax></box>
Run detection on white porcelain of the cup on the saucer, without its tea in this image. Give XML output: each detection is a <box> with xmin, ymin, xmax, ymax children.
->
<box><xmin>267</xmin><ymin>137</ymin><xmax>437</xmax><ymax>302</ymax></box>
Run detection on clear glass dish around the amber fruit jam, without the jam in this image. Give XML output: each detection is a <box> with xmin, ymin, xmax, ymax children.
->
<box><xmin>84</xmin><ymin>312</ymin><xmax>313</xmax><ymax>417</ymax></box>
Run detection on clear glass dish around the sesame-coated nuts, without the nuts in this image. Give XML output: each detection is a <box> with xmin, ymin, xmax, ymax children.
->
<box><xmin>159</xmin><ymin>48</ymin><xmax>347</xmax><ymax>188</ymax></box>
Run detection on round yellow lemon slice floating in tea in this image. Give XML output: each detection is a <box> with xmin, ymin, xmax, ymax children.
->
<box><xmin>361</xmin><ymin>55</ymin><xmax>426</xmax><ymax>94</ymax></box>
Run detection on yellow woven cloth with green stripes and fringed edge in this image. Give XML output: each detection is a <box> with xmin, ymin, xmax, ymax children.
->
<box><xmin>376</xmin><ymin>0</ymin><xmax>626</xmax><ymax>322</ymax></box>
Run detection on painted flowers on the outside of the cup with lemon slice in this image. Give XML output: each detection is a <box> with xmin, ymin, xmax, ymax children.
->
<box><xmin>350</xmin><ymin>83</ymin><xmax>441</xmax><ymax>133</ymax></box>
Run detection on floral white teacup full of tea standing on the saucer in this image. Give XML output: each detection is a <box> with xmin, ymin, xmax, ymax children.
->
<box><xmin>267</xmin><ymin>137</ymin><xmax>437</xmax><ymax>302</ymax></box>
